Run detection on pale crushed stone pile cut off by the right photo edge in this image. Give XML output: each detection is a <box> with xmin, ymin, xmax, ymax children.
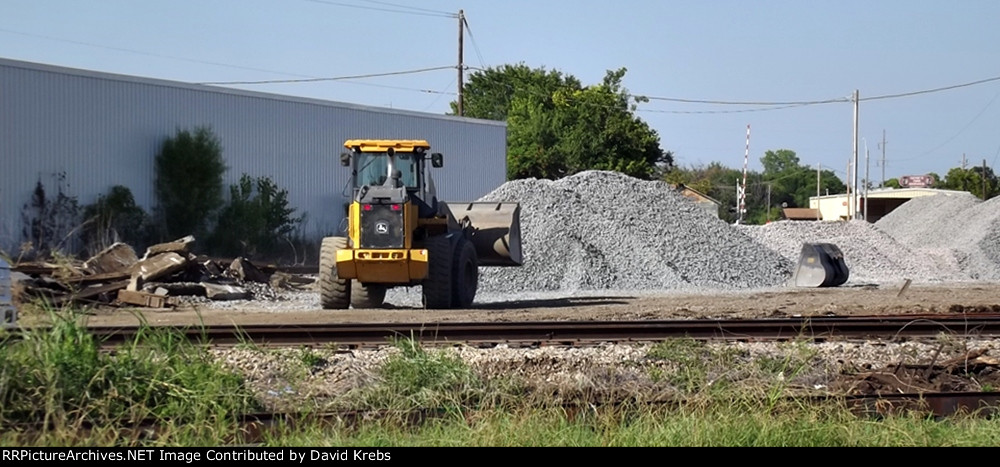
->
<box><xmin>875</xmin><ymin>193</ymin><xmax>1000</xmax><ymax>280</ymax></box>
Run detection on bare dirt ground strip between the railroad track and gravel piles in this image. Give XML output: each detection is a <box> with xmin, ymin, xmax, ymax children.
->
<box><xmin>31</xmin><ymin>282</ymin><xmax>1000</xmax><ymax>326</ymax></box>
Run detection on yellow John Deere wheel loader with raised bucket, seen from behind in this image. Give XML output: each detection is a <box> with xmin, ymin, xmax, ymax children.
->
<box><xmin>319</xmin><ymin>140</ymin><xmax>522</xmax><ymax>309</ymax></box>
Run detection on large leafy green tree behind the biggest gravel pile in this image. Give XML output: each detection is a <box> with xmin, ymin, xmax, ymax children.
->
<box><xmin>452</xmin><ymin>65</ymin><xmax>673</xmax><ymax>179</ymax></box>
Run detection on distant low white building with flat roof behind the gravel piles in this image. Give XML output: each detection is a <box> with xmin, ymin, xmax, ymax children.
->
<box><xmin>809</xmin><ymin>188</ymin><xmax>968</xmax><ymax>222</ymax></box>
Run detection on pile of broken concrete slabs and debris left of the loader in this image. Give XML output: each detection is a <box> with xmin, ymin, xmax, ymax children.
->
<box><xmin>12</xmin><ymin>236</ymin><xmax>302</xmax><ymax>308</ymax></box>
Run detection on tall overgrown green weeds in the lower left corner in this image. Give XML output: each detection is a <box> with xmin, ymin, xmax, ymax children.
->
<box><xmin>0</xmin><ymin>312</ymin><xmax>259</xmax><ymax>445</ymax></box>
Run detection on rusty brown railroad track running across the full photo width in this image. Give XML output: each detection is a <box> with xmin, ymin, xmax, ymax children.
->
<box><xmin>15</xmin><ymin>314</ymin><xmax>1000</xmax><ymax>349</ymax></box>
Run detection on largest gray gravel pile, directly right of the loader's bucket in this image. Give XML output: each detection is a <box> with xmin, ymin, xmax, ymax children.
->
<box><xmin>479</xmin><ymin>171</ymin><xmax>791</xmax><ymax>293</ymax></box>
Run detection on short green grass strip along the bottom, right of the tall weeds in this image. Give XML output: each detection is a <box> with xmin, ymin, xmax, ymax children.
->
<box><xmin>267</xmin><ymin>401</ymin><xmax>1000</xmax><ymax>447</ymax></box>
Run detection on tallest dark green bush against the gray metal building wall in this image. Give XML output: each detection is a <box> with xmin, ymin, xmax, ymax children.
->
<box><xmin>155</xmin><ymin>127</ymin><xmax>227</xmax><ymax>245</ymax></box>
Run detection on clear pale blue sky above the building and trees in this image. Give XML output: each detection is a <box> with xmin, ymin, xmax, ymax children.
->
<box><xmin>0</xmin><ymin>0</ymin><xmax>1000</xmax><ymax>184</ymax></box>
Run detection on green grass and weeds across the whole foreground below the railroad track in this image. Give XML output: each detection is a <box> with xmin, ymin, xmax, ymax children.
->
<box><xmin>0</xmin><ymin>314</ymin><xmax>1000</xmax><ymax>447</ymax></box>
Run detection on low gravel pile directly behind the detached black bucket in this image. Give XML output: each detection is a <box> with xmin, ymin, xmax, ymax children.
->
<box><xmin>737</xmin><ymin>221</ymin><xmax>968</xmax><ymax>284</ymax></box>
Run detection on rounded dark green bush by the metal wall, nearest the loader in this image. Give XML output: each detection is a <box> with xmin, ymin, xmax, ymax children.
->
<box><xmin>210</xmin><ymin>174</ymin><xmax>305</xmax><ymax>257</ymax></box>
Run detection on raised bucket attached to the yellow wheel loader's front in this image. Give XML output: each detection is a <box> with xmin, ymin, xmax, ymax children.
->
<box><xmin>448</xmin><ymin>202</ymin><xmax>523</xmax><ymax>266</ymax></box>
